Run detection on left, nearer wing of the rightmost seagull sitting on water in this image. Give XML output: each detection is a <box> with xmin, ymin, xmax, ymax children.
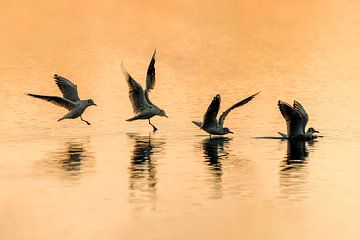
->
<box><xmin>278</xmin><ymin>100</ymin><xmax>304</xmax><ymax>137</ymax></box>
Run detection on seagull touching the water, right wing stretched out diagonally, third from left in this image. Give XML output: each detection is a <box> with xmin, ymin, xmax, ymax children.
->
<box><xmin>192</xmin><ymin>92</ymin><xmax>260</xmax><ymax>137</ymax></box>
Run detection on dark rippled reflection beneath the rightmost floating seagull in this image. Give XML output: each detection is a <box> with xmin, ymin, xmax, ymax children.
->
<box><xmin>279</xmin><ymin>141</ymin><xmax>314</xmax><ymax>200</ymax></box>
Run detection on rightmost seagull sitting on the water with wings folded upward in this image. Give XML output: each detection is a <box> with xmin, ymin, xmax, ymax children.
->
<box><xmin>278</xmin><ymin>100</ymin><xmax>319</xmax><ymax>140</ymax></box>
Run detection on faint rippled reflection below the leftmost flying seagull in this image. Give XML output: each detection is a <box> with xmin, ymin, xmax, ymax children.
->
<box><xmin>36</xmin><ymin>139</ymin><xmax>95</xmax><ymax>180</ymax></box>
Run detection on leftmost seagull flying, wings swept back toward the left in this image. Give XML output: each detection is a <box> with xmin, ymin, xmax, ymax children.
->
<box><xmin>27</xmin><ymin>74</ymin><xmax>97</xmax><ymax>125</ymax></box>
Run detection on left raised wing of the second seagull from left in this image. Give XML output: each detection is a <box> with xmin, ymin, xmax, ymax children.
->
<box><xmin>121</xmin><ymin>64</ymin><xmax>150</xmax><ymax>113</ymax></box>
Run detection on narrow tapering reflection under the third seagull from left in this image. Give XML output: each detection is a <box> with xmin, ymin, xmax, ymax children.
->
<box><xmin>202</xmin><ymin>137</ymin><xmax>231</xmax><ymax>198</ymax></box>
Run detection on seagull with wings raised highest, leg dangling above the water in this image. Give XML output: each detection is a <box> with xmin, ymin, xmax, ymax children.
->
<box><xmin>121</xmin><ymin>50</ymin><xmax>168</xmax><ymax>132</ymax></box>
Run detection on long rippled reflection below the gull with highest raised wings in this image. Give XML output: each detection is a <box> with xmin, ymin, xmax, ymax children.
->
<box><xmin>128</xmin><ymin>134</ymin><xmax>164</xmax><ymax>202</ymax></box>
